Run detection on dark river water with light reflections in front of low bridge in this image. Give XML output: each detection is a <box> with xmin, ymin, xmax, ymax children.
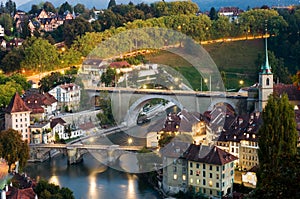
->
<box><xmin>25</xmin><ymin>154</ymin><xmax>161</xmax><ymax>199</ymax></box>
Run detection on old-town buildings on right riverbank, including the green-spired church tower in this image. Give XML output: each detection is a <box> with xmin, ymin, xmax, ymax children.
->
<box><xmin>147</xmin><ymin>35</ymin><xmax>300</xmax><ymax>198</ymax></box>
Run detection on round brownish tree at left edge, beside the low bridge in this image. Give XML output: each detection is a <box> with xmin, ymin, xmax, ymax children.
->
<box><xmin>0</xmin><ymin>129</ymin><xmax>29</xmax><ymax>171</ymax></box>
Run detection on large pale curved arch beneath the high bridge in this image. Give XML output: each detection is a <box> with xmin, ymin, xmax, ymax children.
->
<box><xmin>124</xmin><ymin>95</ymin><xmax>184</xmax><ymax>126</ymax></box>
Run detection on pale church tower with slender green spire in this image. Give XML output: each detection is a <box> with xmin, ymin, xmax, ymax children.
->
<box><xmin>258</xmin><ymin>33</ymin><xmax>273</xmax><ymax>112</ymax></box>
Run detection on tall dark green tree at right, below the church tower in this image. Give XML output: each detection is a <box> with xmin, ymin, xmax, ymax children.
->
<box><xmin>255</xmin><ymin>94</ymin><xmax>300</xmax><ymax>198</ymax></box>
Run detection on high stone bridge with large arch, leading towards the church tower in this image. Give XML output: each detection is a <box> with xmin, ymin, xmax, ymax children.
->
<box><xmin>86</xmin><ymin>87</ymin><xmax>250</xmax><ymax>126</ymax></box>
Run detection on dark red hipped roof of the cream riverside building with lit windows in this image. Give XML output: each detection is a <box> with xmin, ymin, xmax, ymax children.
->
<box><xmin>184</xmin><ymin>144</ymin><xmax>238</xmax><ymax>165</ymax></box>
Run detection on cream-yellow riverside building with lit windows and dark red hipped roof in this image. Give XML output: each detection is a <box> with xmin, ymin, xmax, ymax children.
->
<box><xmin>184</xmin><ymin>144</ymin><xmax>237</xmax><ymax>198</ymax></box>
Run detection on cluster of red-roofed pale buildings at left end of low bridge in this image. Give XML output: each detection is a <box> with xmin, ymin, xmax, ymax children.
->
<box><xmin>4</xmin><ymin>83</ymin><xmax>87</xmax><ymax>144</ymax></box>
